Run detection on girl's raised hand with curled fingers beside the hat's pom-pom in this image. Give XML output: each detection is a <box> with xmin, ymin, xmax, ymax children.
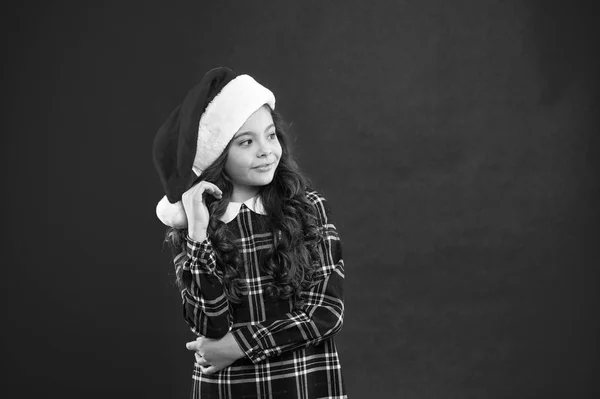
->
<box><xmin>181</xmin><ymin>180</ymin><xmax>223</xmax><ymax>241</ymax></box>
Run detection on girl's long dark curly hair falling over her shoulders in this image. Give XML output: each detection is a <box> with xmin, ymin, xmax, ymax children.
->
<box><xmin>165</xmin><ymin>106</ymin><xmax>322</xmax><ymax>306</ymax></box>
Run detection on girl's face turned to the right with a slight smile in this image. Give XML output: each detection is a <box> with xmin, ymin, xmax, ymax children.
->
<box><xmin>225</xmin><ymin>106</ymin><xmax>281</xmax><ymax>201</ymax></box>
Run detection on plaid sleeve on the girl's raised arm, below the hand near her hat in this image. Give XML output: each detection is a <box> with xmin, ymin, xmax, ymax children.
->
<box><xmin>181</xmin><ymin>237</ymin><xmax>231</xmax><ymax>338</ymax></box>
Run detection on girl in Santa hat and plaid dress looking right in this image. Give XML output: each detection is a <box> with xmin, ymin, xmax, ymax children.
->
<box><xmin>154</xmin><ymin>68</ymin><xmax>347</xmax><ymax>398</ymax></box>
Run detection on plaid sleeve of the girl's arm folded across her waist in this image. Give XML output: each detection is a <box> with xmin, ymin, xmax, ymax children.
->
<box><xmin>232</xmin><ymin>193</ymin><xmax>344</xmax><ymax>363</ymax></box>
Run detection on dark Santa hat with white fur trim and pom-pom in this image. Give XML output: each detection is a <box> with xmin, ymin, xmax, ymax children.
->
<box><xmin>153</xmin><ymin>67</ymin><xmax>275</xmax><ymax>228</ymax></box>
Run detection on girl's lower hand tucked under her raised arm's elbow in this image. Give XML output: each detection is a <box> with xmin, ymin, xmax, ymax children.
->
<box><xmin>185</xmin><ymin>333</ymin><xmax>246</xmax><ymax>374</ymax></box>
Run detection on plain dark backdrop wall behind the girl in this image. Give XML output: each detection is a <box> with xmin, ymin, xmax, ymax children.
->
<box><xmin>2</xmin><ymin>0</ymin><xmax>600</xmax><ymax>399</ymax></box>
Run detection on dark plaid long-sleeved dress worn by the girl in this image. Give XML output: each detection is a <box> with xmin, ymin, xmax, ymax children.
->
<box><xmin>182</xmin><ymin>191</ymin><xmax>347</xmax><ymax>399</ymax></box>
